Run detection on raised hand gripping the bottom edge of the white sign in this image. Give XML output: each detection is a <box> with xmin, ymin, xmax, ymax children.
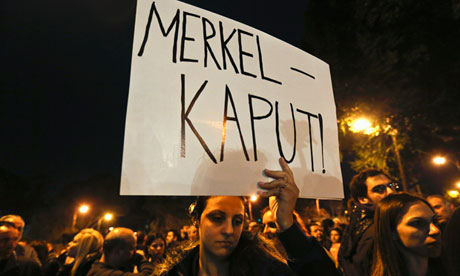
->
<box><xmin>258</xmin><ymin>158</ymin><xmax>299</xmax><ymax>231</ymax></box>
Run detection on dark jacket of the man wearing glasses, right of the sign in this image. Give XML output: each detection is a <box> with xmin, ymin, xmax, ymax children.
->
<box><xmin>338</xmin><ymin>204</ymin><xmax>374</xmax><ymax>276</ymax></box>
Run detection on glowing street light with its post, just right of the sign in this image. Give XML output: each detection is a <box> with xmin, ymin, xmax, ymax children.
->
<box><xmin>348</xmin><ymin>118</ymin><xmax>407</xmax><ymax>191</ymax></box>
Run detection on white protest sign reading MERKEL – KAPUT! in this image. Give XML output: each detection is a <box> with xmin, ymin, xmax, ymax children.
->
<box><xmin>121</xmin><ymin>0</ymin><xmax>343</xmax><ymax>198</ymax></box>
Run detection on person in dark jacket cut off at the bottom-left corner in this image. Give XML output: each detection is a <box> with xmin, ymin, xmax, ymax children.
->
<box><xmin>0</xmin><ymin>221</ymin><xmax>41</xmax><ymax>276</ymax></box>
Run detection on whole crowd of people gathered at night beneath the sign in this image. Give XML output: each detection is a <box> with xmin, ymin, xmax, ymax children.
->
<box><xmin>0</xmin><ymin>159</ymin><xmax>460</xmax><ymax>276</ymax></box>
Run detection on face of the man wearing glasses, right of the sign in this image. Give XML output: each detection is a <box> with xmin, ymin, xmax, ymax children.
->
<box><xmin>359</xmin><ymin>174</ymin><xmax>396</xmax><ymax>205</ymax></box>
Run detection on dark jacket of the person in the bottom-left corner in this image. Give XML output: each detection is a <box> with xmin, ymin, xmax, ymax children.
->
<box><xmin>0</xmin><ymin>254</ymin><xmax>40</xmax><ymax>276</ymax></box>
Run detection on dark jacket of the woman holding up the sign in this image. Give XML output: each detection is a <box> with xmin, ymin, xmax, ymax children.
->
<box><xmin>162</xmin><ymin>225</ymin><xmax>338</xmax><ymax>276</ymax></box>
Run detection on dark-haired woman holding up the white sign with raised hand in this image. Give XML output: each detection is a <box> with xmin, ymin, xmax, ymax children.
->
<box><xmin>156</xmin><ymin>159</ymin><xmax>335</xmax><ymax>276</ymax></box>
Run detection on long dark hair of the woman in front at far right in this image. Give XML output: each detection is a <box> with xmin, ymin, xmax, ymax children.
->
<box><xmin>372</xmin><ymin>193</ymin><xmax>434</xmax><ymax>276</ymax></box>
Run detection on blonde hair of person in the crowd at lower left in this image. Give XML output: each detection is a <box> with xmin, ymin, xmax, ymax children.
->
<box><xmin>70</xmin><ymin>228</ymin><xmax>104</xmax><ymax>276</ymax></box>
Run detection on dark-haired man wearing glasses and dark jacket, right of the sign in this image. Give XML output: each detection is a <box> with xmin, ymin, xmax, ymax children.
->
<box><xmin>339</xmin><ymin>168</ymin><xmax>399</xmax><ymax>276</ymax></box>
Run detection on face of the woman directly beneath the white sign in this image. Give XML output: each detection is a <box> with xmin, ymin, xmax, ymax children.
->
<box><xmin>199</xmin><ymin>196</ymin><xmax>244</xmax><ymax>260</ymax></box>
